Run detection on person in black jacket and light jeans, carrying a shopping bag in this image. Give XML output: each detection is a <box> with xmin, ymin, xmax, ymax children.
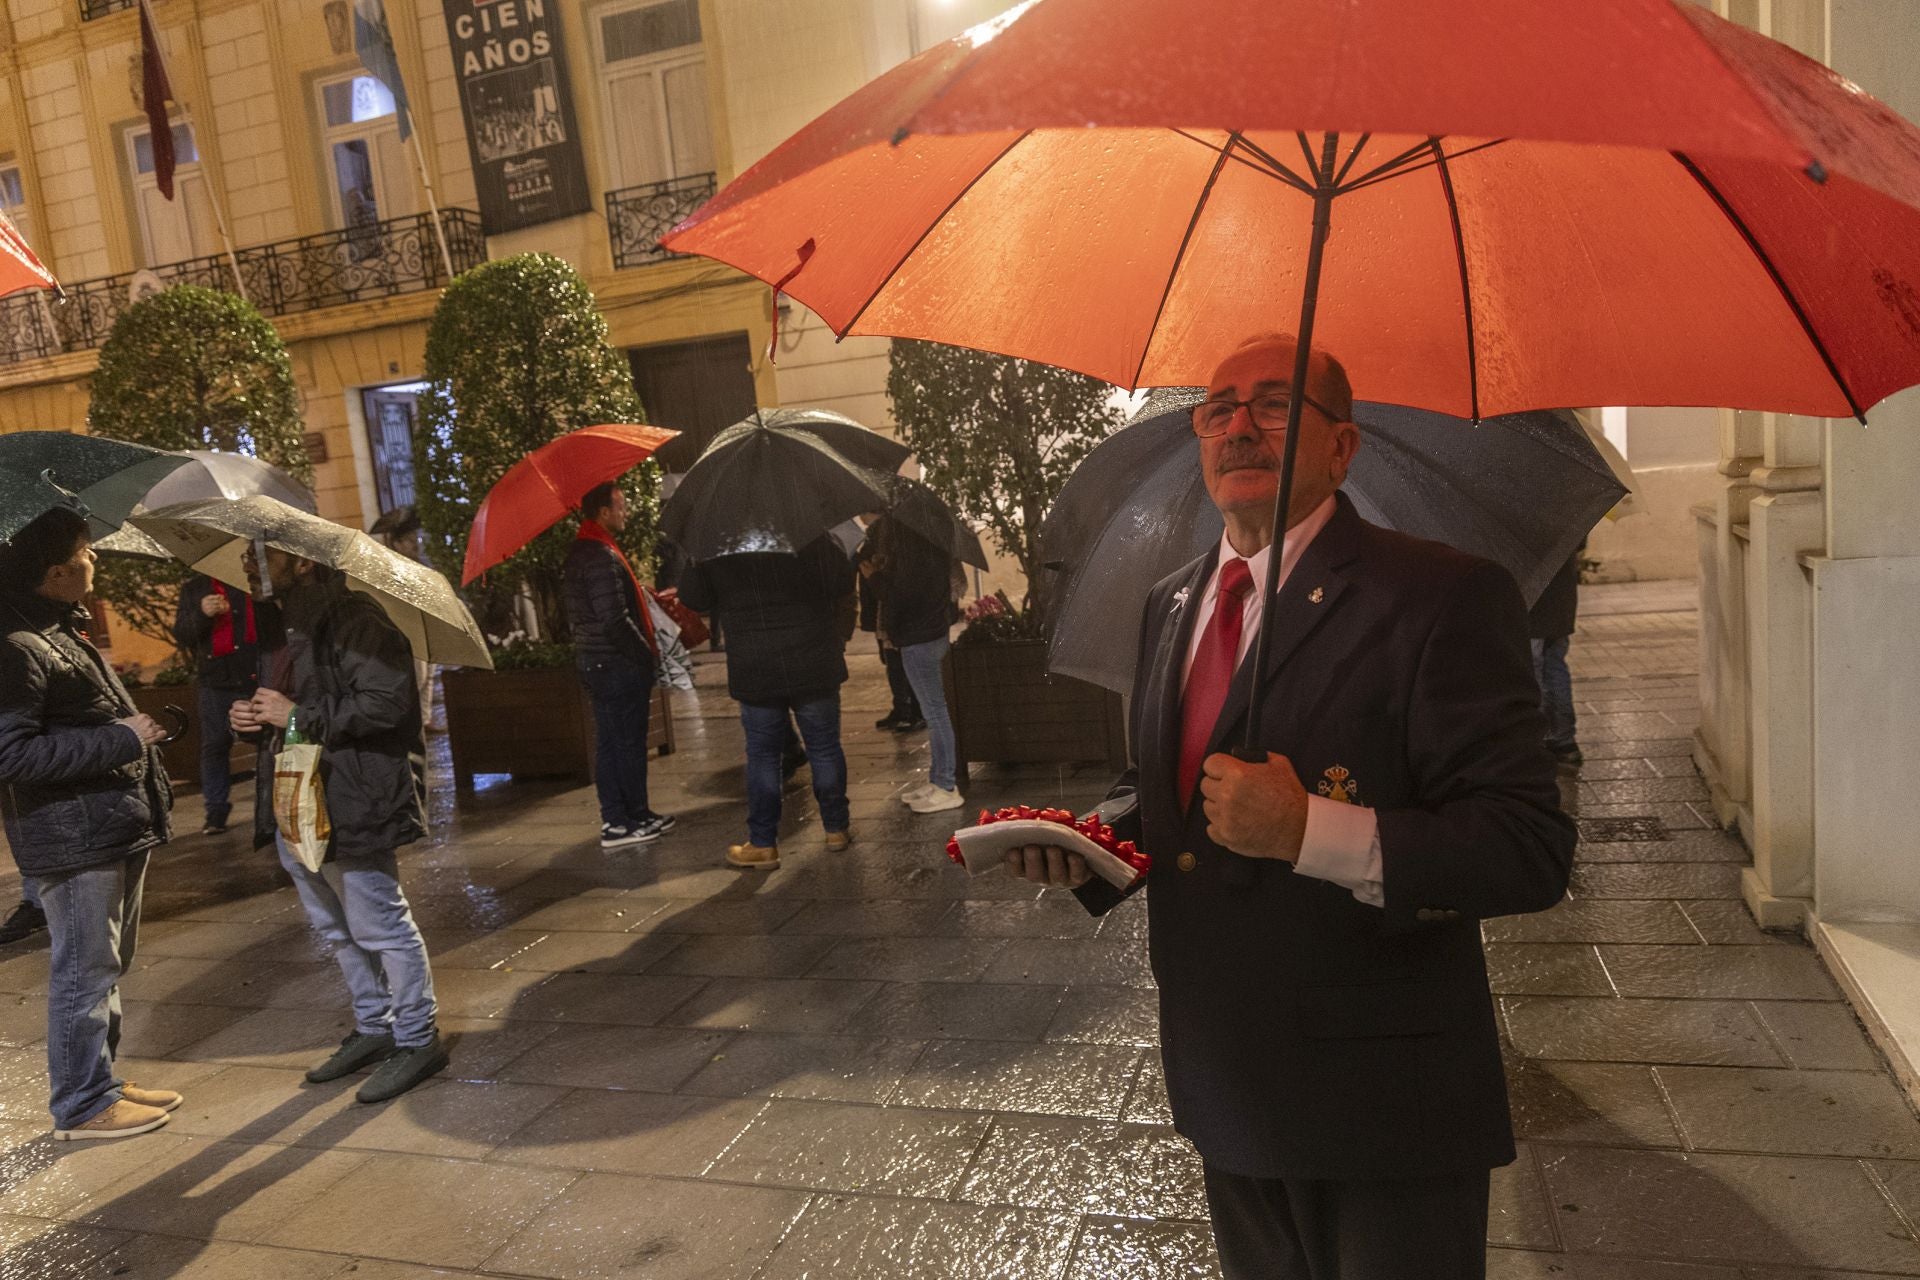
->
<box><xmin>228</xmin><ymin>547</ymin><xmax>447</xmax><ymax>1102</ymax></box>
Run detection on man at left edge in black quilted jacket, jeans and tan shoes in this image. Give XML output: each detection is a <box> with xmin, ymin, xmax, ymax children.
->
<box><xmin>0</xmin><ymin>509</ymin><xmax>180</xmax><ymax>1138</ymax></box>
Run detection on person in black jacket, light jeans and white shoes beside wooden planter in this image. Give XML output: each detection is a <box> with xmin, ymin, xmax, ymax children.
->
<box><xmin>862</xmin><ymin>514</ymin><xmax>964</xmax><ymax>814</ymax></box>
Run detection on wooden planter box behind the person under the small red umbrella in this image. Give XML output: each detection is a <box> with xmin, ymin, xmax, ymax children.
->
<box><xmin>440</xmin><ymin>666</ymin><xmax>674</xmax><ymax>791</ymax></box>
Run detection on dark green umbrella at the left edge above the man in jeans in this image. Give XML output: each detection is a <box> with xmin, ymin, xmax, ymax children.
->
<box><xmin>0</xmin><ymin>432</ymin><xmax>188</xmax><ymax>539</ymax></box>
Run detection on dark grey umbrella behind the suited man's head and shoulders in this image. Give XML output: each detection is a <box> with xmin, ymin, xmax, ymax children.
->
<box><xmin>1041</xmin><ymin>388</ymin><xmax>1626</xmax><ymax>693</ymax></box>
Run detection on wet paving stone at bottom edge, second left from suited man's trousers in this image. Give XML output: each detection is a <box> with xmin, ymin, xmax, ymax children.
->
<box><xmin>758</xmin><ymin>1196</ymin><xmax>1077</xmax><ymax>1280</ymax></box>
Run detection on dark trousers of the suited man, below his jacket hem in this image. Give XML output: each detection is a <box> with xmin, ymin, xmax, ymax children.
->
<box><xmin>1206</xmin><ymin>1165</ymin><xmax>1488</xmax><ymax>1280</ymax></box>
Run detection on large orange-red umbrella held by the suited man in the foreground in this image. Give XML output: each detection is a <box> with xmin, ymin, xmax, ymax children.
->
<box><xmin>664</xmin><ymin>0</ymin><xmax>1920</xmax><ymax>741</ymax></box>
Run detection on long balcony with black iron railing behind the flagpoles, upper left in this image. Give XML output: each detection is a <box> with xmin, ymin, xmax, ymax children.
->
<box><xmin>0</xmin><ymin>209</ymin><xmax>486</xmax><ymax>365</ymax></box>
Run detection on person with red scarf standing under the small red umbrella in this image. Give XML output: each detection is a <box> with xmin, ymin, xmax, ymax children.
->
<box><xmin>564</xmin><ymin>482</ymin><xmax>674</xmax><ymax>848</ymax></box>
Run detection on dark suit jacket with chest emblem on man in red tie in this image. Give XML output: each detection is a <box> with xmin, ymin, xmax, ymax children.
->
<box><xmin>1079</xmin><ymin>497</ymin><xmax>1574</xmax><ymax>1178</ymax></box>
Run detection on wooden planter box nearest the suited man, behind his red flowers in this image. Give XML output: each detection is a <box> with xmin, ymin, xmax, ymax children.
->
<box><xmin>945</xmin><ymin>641</ymin><xmax>1127</xmax><ymax>779</ymax></box>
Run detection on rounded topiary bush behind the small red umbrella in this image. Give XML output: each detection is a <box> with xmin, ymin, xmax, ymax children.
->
<box><xmin>413</xmin><ymin>253</ymin><xmax>660</xmax><ymax>643</ymax></box>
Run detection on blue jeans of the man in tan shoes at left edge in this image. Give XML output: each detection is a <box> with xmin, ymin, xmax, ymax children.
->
<box><xmin>35</xmin><ymin>852</ymin><xmax>146</xmax><ymax>1128</ymax></box>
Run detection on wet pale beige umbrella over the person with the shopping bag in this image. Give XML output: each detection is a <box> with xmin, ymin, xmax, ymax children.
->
<box><xmin>132</xmin><ymin>497</ymin><xmax>493</xmax><ymax>668</ymax></box>
